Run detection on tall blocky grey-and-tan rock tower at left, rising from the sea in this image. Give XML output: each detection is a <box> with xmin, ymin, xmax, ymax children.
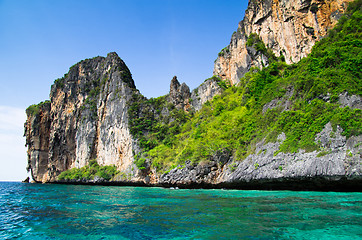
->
<box><xmin>25</xmin><ymin>53</ymin><xmax>140</xmax><ymax>182</ymax></box>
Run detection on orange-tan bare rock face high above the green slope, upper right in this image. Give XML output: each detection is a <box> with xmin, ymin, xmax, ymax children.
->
<box><xmin>214</xmin><ymin>0</ymin><xmax>352</xmax><ymax>84</ymax></box>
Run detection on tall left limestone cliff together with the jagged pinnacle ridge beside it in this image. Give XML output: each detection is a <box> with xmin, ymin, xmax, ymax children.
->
<box><xmin>24</xmin><ymin>59</ymin><xmax>221</xmax><ymax>182</ymax></box>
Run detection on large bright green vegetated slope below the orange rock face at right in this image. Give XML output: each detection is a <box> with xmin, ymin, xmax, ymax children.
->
<box><xmin>139</xmin><ymin>0</ymin><xmax>362</xmax><ymax>171</ymax></box>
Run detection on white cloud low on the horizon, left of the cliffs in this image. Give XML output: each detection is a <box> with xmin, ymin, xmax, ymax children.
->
<box><xmin>0</xmin><ymin>106</ymin><xmax>27</xmax><ymax>181</ymax></box>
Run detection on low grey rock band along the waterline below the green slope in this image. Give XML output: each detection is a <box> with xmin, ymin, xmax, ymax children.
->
<box><xmin>160</xmin><ymin>123</ymin><xmax>362</xmax><ymax>190</ymax></box>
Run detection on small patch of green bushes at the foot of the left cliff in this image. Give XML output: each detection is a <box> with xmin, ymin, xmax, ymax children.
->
<box><xmin>58</xmin><ymin>159</ymin><xmax>119</xmax><ymax>181</ymax></box>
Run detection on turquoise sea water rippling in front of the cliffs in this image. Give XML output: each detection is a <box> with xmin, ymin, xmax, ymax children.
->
<box><xmin>0</xmin><ymin>183</ymin><xmax>362</xmax><ymax>240</ymax></box>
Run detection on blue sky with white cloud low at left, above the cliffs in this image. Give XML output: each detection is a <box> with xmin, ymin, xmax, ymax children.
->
<box><xmin>0</xmin><ymin>0</ymin><xmax>248</xmax><ymax>181</ymax></box>
